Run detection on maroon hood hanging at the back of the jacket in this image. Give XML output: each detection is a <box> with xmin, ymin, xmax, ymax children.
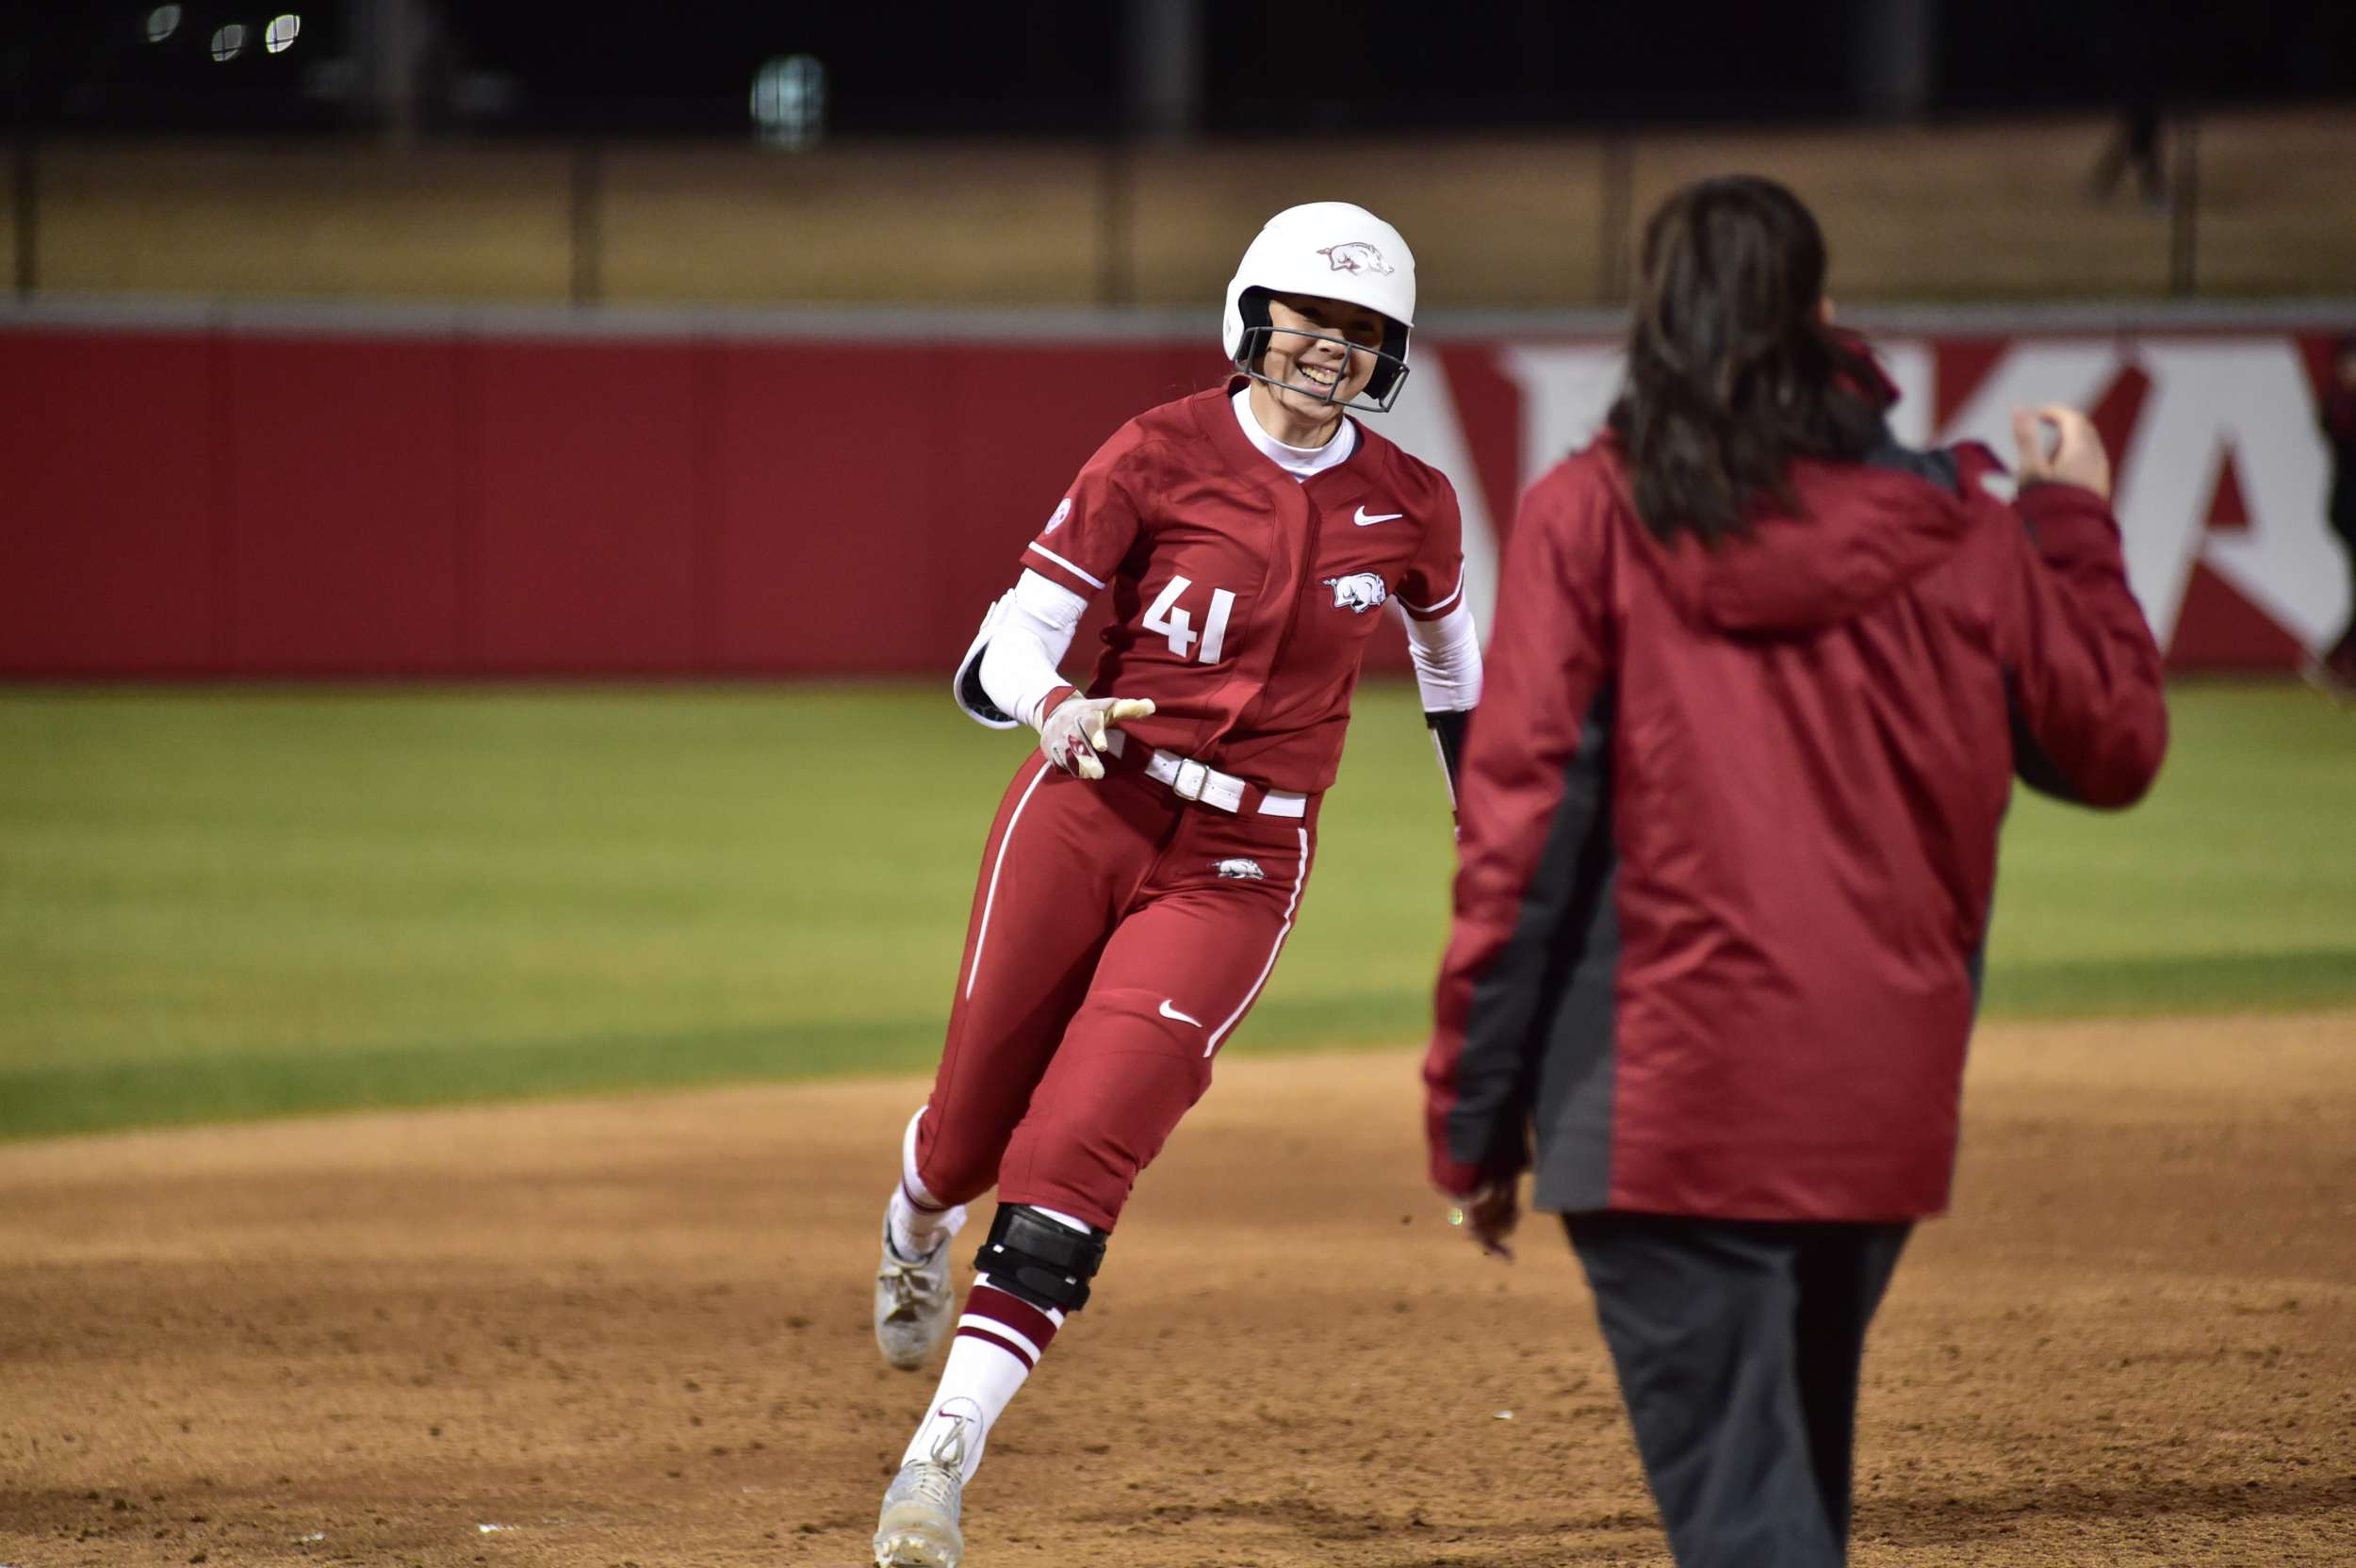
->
<box><xmin>1621</xmin><ymin>448</ymin><xmax>1998</xmax><ymax>636</ymax></box>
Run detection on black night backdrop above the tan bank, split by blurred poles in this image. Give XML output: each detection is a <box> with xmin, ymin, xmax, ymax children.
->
<box><xmin>0</xmin><ymin>0</ymin><xmax>2356</xmax><ymax>137</ymax></box>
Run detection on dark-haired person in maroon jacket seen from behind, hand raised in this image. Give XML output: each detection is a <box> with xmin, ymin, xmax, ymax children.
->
<box><xmin>1426</xmin><ymin>176</ymin><xmax>2168</xmax><ymax>1568</ymax></box>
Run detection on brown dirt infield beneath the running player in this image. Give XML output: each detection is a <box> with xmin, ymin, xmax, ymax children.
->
<box><xmin>0</xmin><ymin>1012</ymin><xmax>2356</xmax><ymax>1568</ymax></box>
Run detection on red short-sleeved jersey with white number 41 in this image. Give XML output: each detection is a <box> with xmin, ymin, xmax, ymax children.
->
<box><xmin>1023</xmin><ymin>379</ymin><xmax>1464</xmax><ymax>793</ymax></box>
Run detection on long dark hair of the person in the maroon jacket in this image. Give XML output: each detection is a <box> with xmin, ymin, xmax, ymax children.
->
<box><xmin>1612</xmin><ymin>174</ymin><xmax>1892</xmax><ymax>547</ymax></box>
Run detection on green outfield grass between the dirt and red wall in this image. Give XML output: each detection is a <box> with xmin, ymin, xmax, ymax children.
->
<box><xmin>0</xmin><ymin>683</ymin><xmax>2356</xmax><ymax>1137</ymax></box>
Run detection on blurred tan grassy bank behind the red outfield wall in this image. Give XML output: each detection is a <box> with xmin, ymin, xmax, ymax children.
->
<box><xmin>13</xmin><ymin>106</ymin><xmax>2356</xmax><ymax>311</ymax></box>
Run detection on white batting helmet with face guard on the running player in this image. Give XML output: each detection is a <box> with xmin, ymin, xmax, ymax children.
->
<box><xmin>1220</xmin><ymin>203</ymin><xmax>1416</xmax><ymax>412</ymax></box>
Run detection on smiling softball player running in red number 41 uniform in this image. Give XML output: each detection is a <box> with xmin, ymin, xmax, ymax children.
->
<box><xmin>875</xmin><ymin>203</ymin><xmax>1480</xmax><ymax>1568</ymax></box>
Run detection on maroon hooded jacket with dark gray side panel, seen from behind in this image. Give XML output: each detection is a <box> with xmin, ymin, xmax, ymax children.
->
<box><xmin>1426</xmin><ymin>438</ymin><xmax>2168</xmax><ymax>1219</ymax></box>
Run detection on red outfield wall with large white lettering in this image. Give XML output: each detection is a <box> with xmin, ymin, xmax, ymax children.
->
<box><xmin>0</xmin><ymin>322</ymin><xmax>2347</xmax><ymax>678</ymax></box>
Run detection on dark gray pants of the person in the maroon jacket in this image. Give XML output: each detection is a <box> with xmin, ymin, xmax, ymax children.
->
<box><xmin>1564</xmin><ymin>1213</ymin><xmax>1913</xmax><ymax>1568</ymax></box>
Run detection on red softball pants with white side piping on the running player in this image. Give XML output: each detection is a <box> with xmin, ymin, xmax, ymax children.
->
<box><xmin>917</xmin><ymin>756</ymin><xmax>1317</xmax><ymax>1232</ymax></box>
